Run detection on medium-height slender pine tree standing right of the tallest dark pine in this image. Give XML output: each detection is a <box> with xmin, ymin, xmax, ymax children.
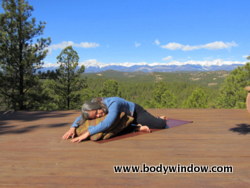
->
<box><xmin>54</xmin><ymin>46</ymin><xmax>86</xmax><ymax>109</ymax></box>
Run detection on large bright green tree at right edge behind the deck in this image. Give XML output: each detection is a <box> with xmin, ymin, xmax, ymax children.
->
<box><xmin>217</xmin><ymin>63</ymin><xmax>250</xmax><ymax>108</ymax></box>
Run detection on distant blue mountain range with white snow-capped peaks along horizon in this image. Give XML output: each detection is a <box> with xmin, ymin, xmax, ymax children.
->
<box><xmin>40</xmin><ymin>60</ymin><xmax>245</xmax><ymax>73</ymax></box>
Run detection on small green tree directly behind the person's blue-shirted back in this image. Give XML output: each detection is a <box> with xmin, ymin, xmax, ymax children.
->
<box><xmin>100</xmin><ymin>80</ymin><xmax>120</xmax><ymax>97</ymax></box>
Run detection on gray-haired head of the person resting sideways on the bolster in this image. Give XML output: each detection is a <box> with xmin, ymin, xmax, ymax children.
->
<box><xmin>82</xmin><ymin>101</ymin><xmax>106</xmax><ymax>119</ymax></box>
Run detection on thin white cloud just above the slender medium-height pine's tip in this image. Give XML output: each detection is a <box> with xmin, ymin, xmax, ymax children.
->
<box><xmin>48</xmin><ymin>41</ymin><xmax>100</xmax><ymax>51</ymax></box>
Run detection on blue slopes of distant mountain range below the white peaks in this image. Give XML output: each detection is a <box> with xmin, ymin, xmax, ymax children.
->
<box><xmin>40</xmin><ymin>64</ymin><xmax>243</xmax><ymax>73</ymax></box>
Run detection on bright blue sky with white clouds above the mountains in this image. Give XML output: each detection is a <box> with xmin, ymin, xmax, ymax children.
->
<box><xmin>1</xmin><ymin>0</ymin><xmax>250</xmax><ymax>65</ymax></box>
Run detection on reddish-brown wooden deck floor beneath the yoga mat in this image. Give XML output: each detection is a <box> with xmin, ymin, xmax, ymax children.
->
<box><xmin>0</xmin><ymin>109</ymin><xmax>250</xmax><ymax>188</ymax></box>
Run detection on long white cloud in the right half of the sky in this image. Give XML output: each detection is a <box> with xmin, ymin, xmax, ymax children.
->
<box><xmin>161</xmin><ymin>41</ymin><xmax>238</xmax><ymax>51</ymax></box>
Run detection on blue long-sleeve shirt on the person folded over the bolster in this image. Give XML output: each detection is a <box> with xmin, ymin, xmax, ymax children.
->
<box><xmin>71</xmin><ymin>97</ymin><xmax>135</xmax><ymax>135</ymax></box>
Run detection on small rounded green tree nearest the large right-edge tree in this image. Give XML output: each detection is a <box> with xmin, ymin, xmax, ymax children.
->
<box><xmin>184</xmin><ymin>88</ymin><xmax>208</xmax><ymax>108</ymax></box>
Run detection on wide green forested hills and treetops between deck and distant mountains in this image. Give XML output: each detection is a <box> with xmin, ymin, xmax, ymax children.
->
<box><xmin>1</xmin><ymin>64</ymin><xmax>250</xmax><ymax>110</ymax></box>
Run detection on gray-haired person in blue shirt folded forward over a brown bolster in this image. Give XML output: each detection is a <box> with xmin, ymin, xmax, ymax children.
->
<box><xmin>62</xmin><ymin>97</ymin><xmax>166</xmax><ymax>142</ymax></box>
